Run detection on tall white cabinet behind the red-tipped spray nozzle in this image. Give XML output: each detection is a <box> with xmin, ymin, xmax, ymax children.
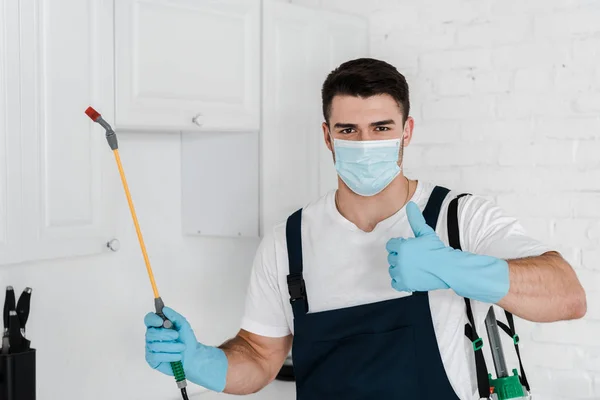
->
<box><xmin>0</xmin><ymin>0</ymin><xmax>117</xmax><ymax>264</ymax></box>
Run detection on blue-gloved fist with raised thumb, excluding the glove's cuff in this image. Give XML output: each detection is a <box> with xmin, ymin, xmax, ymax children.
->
<box><xmin>386</xmin><ymin>201</ymin><xmax>453</xmax><ymax>292</ymax></box>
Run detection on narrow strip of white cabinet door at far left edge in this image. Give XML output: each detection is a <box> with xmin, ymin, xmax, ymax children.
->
<box><xmin>0</xmin><ymin>0</ymin><xmax>23</xmax><ymax>264</ymax></box>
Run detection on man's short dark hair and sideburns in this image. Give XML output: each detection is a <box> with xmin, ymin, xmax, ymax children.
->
<box><xmin>321</xmin><ymin>58</ymin><xmax>410</xmax><ymax>123</ymax></box>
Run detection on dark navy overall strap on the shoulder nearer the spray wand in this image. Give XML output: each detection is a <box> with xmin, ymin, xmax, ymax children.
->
<box><xmin>285</xmin><ymin>209</ymin><xmax>308</xmax><ymax>318</ymax></box>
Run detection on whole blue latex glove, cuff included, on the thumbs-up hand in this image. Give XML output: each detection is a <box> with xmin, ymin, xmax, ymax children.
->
<box><xmin>386</xmin><ymin>201</ymin><xmax>510</xmax><ymax>303</ymax></box>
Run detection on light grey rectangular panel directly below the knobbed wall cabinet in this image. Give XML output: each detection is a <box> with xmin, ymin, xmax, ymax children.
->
<box><xmin>181</xmin><ymin>132</ymin><xmax>260</xmax><ymax>238</ymax></box>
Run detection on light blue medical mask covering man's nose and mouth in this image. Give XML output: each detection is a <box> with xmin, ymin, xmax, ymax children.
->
<box><xmin>333</xmin><ymin>139</ymin><xmax>401</xmax><ymax>196</ymax></box>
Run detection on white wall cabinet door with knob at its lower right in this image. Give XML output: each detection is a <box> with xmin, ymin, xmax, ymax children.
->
<box><xmin>115</xmin><ymin>0</ymin><xmax>260</xmax><ymax>131</ymax></box>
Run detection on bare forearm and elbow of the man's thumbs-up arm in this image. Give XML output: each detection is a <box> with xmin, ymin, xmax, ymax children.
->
<box><xmin>498</xmin><ymin>252</ymin><xmax>586</xmax><ymax>322</ymax></box>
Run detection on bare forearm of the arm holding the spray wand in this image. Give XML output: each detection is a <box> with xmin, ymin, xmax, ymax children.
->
<box><xmin>219</xmin><ymin>332</ymin><xmax>291</xmax><ymax>394</ymax></box>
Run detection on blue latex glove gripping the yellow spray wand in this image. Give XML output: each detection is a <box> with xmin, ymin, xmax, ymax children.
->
<box><xmin>144</xmin><ymin>307</ymin><xmax>228</xmax><ymax>392</ymax></box>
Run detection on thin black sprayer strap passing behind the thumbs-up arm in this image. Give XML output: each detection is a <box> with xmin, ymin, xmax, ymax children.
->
<box><xmin>448</xmin><ymin>193</ymin><xmax>490</xmax><ymax>399</ymax></box>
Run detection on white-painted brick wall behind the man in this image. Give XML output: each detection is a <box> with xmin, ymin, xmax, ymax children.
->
<box><xmin>366</xmin><ymin>0</ymin><xmax>600</xmax><ymax>400</ymax></box>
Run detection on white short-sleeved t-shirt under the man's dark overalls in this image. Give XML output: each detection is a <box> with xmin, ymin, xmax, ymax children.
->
<box><xmin>241</xmin><ymin>181</ymin><xmax>550</xmax><ymax>399</ymax></box>
